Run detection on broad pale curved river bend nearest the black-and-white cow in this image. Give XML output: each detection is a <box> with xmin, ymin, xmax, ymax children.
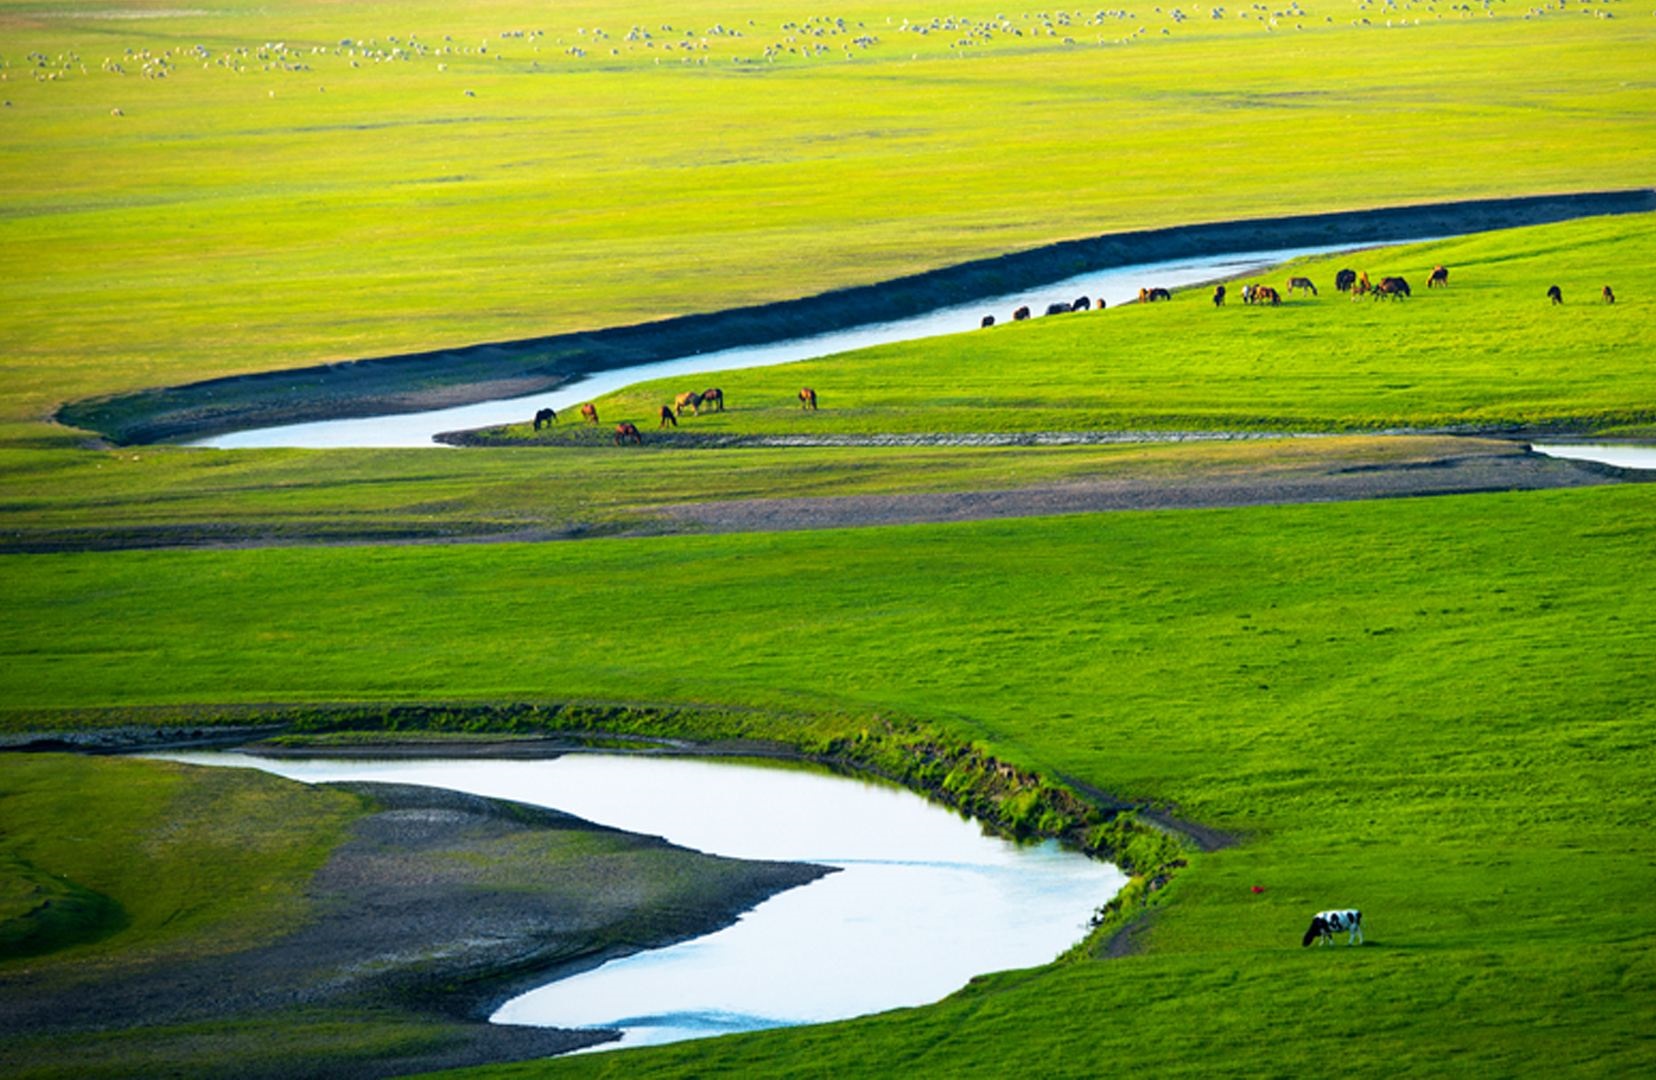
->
<box><xmin>162</xmin><ymin>752</ymin><xmax>1126</xmax><ymax>1050</ymax></box>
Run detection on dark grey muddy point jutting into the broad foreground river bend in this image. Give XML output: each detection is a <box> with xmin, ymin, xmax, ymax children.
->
<box><xmin>0</xmin><ymin>783</ymin><xmax>830</xmax><ymax>1077</ymax></box>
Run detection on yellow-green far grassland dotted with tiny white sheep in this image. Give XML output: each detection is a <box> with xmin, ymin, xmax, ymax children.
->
<box><xmin>0</xmin><ymin>0</ymin><xmax>1656</xmax><ymax>441</ymax></box>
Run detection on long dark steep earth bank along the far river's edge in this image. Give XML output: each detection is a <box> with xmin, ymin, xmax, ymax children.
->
<box><xmin>53</xmin><ymin>189</ymin><xmax>1656</xmax><ymax>444</ymax></box>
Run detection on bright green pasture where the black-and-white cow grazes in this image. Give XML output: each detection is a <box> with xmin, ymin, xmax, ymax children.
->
<box><xmin>0</xmin><ymin>487</ymin><xmax>1656</xmax><ymax>1075</ymax></box>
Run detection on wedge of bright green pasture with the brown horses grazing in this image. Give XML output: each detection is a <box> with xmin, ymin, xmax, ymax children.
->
<box><xmin>513</xmin><ymin>215</ymin><xmax>1656</xmax><ymax>439</ymax></box>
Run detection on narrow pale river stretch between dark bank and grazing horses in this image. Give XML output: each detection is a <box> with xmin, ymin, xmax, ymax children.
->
<box><xmin>190</xmin><ymin>240</ymin><xmax>1418</xmax><ymax>449</ymax></box>
